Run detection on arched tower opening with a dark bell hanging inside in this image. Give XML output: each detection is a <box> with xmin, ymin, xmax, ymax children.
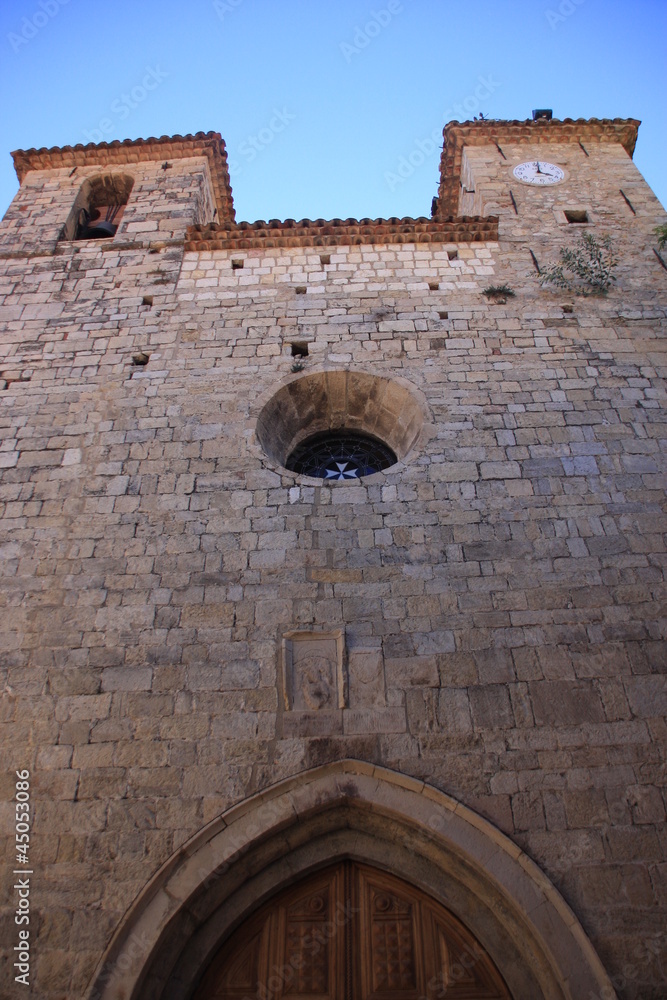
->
<box><xmin>61</xmin><ymin>174</ymin><xmax>134</xmax><ymax>240</ymax></box>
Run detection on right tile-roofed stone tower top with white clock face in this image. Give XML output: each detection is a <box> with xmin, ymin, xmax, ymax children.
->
<box><xmin>438</xmin><ymin>118</ymin><xmax>661</xmax><ymax>252</ymax></box>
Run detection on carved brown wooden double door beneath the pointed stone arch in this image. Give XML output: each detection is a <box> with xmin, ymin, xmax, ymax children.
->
<box><xmin>194</xmin><ymin>861</ymin><xmax>512</xmax><ymax>1000</ymax></box>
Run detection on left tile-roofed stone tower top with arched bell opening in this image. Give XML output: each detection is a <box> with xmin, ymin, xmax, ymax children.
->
<box><xmin>0</xmin><ymin>132</ymin><xmax>234</xmax><ymax>254</ymax></box>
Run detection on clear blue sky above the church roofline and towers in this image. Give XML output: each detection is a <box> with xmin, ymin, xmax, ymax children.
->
<box><xmin>0</xmin><ymin>0</ymin><xmax>667</xmax><ymax>221</ymax></box>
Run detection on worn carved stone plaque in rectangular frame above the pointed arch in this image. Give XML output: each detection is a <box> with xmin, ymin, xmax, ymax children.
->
<box><xmin>283</xmin><ymin>629</ymin><xmax>345</xmax><ymax>712</ymax></box>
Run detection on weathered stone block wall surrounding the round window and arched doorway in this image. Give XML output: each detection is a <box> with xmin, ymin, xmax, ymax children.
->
<box><xmin>0</xmin><ymin>129</ymin><xmax>667</xmax><ymax>1000</ymax></box>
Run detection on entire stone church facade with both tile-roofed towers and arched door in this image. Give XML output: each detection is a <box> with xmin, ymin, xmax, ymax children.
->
<box><xmin>0</xmin><ymin>118</ymin><xmax>667</xmax><ymax>1000</ymax></box>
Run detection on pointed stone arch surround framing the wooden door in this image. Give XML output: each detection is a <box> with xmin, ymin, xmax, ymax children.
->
<box><xmin>87</xmin><ymin>761</ymin><xmax>614</xmax><ymax>1000</ymax></box>
